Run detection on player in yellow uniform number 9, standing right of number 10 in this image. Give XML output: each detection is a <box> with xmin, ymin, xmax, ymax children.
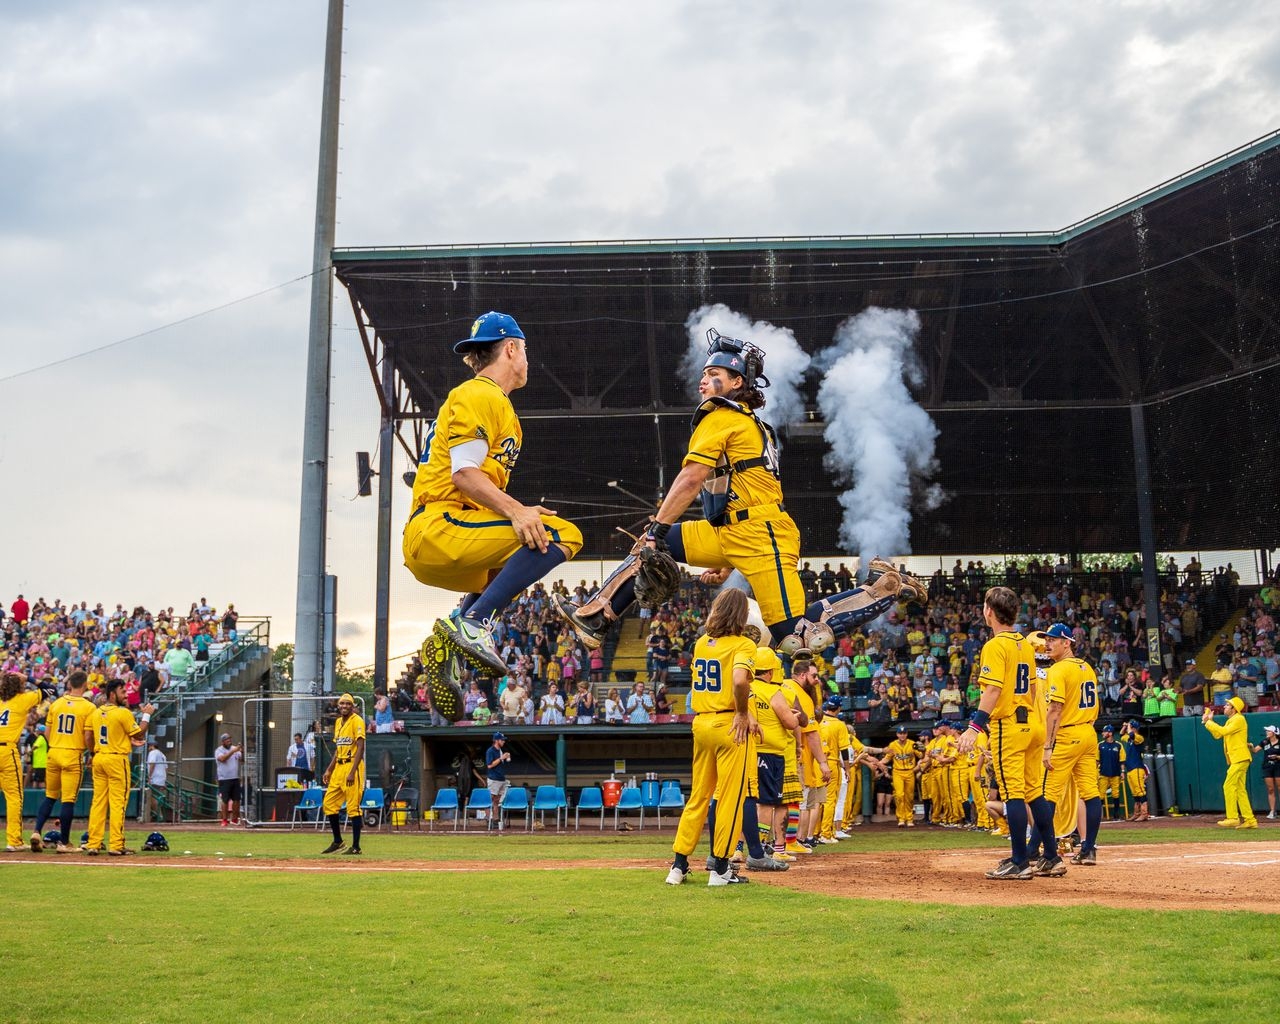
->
<box><xmin>84</xmin><ymin>680</ymin><xmax>155</xmax><ymax>856</ymax></box>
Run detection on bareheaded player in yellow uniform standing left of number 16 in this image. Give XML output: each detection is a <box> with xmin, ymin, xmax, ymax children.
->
<box><xmin>959</xmin><ymin>586</ymin><xmax>1053</xmax><ymax>881</ymax></box>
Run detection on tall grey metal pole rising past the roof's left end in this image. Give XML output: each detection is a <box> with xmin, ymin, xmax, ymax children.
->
<box><xmin>293</xmin><ymin>0</ymin><xmax>343</xmax><ymax>732</ymax></box>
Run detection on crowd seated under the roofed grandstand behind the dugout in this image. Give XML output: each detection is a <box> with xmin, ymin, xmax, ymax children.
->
<box><xmin>399</xmin><ymin>558</ymin><xmax>1280</xmax><ymax>724</ymax></box>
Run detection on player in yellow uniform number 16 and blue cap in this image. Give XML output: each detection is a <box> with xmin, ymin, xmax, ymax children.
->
<box><xmin>1039</xmin><ymin>622</ymin><xmax>1102</xmax><ymax>874</ymax></box>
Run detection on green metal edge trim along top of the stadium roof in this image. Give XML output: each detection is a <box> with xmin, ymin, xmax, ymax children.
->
<box><xmin>330</xmin><ymin>129</ymin><xmax>1280</xmax><ymax>264</ymax></box>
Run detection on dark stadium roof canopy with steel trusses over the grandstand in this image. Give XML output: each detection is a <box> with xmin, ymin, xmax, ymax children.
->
<box><xmin>333</xmin><ymin>132</ymin><xmax>1280</xmax><ymax>556</ymax></box>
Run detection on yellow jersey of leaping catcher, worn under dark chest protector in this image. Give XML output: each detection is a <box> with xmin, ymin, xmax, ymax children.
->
<box><xmin>682</xmin><ymin>399</ymin><xmax>782</xmax><ymax>513</ymax></box>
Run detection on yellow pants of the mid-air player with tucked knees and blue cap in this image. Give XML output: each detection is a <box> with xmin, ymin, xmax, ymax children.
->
<box><xmin>402</xmin><ymin>502</ymin><xmax>582</xmax><ymax>594</ymax></box>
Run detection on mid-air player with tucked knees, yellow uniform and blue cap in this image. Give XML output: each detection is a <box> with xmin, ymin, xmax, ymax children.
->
<box><xmin>403</xmin><ymin>312</ymin><xmax>582</xmax><ymax>681</ymax></box>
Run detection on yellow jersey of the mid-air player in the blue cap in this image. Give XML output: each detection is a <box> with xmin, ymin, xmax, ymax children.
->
<box><xmin>412</xmin><ymin>376</ymin><xmax>525</xmax><ymax>508</ymax></box>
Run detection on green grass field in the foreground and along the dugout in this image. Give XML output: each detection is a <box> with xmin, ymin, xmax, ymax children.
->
<box><xmin>0</xmin><ymin>826</ymin><xmax>1280</xmax><ymax>1024</ymax></box>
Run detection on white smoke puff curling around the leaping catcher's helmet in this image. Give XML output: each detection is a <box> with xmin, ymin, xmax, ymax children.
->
<box><xmin>678</xmin><ymin>302</ymin><xmax>809</xmax><ymax>429</ymax></box>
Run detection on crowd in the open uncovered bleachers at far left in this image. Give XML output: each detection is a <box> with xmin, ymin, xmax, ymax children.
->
<box><xmin>0</xmin><ymin>594</ymin><xmax>239</xmax><ymax>778</ymax></box>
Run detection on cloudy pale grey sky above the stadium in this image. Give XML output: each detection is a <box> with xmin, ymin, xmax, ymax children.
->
<box><xmin>0</xmin><ymin>0</ymin><xmax>1280</xmax><ymax>664</ymax></box>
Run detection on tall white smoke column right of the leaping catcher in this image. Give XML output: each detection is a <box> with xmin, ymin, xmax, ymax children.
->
<box><xmin>814</xmin><ymin>306</ymin><xmax>943</xmax><ymax>566</ymax></box>
